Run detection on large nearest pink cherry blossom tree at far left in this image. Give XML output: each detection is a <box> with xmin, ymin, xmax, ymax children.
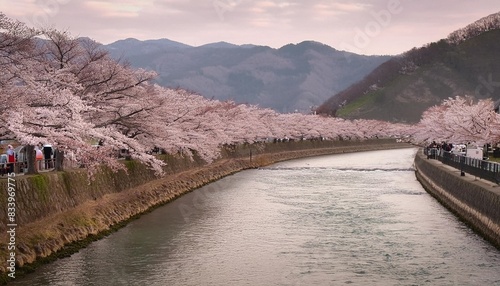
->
<box><xmin>1</xmin><ymin>18</ymin><xmax>165</xmax><ymax>175</ymax></box>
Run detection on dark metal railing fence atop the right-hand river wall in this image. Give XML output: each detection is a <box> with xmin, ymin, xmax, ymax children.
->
<box><xmin>424</xmin><ymin>148</ymin><xmax>500</xmax><ymax>184</ymax></box>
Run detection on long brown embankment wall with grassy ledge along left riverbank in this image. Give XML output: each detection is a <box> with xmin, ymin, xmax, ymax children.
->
<box><xmin>0</xmin><ymin>139</ymin><xmax>410</xmax><ymax>275</ymax></box>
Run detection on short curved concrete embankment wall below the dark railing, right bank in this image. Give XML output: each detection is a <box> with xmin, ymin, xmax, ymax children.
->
<box><xmin>415</xmin><ymin>151</ymin><xmax>500</xmax><ymax>248</ymax></box>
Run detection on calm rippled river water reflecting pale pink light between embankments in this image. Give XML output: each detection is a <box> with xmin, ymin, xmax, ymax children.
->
<box><xmin>12</xmin><ymin>149</ymin><xmax>500</xmax><ymax>286</ymax></box>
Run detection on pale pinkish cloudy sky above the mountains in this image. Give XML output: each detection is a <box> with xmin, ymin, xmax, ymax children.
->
<box><xmin>0</xmin><ymin>0</ymin><xmax>500</xmax><ymax>55</ymax></box>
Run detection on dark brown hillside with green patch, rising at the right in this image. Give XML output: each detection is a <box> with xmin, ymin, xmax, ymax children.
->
<box><xmin>317</xmin><ymin>13</ymin><xmax>500</xmax><ymax>123</ymax></box>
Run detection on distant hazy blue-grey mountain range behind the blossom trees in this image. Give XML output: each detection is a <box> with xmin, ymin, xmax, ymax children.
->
<box><xmin>104</xmin><ymin>39</ymin><xmax>390</xmax><ymax>113</ymax></box>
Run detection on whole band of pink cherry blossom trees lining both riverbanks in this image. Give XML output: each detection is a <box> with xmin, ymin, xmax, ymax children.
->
<box><xmin>8</xmin><ymin>13</ymin><xmax>496</xmax><ymax>177</ymax></box>
